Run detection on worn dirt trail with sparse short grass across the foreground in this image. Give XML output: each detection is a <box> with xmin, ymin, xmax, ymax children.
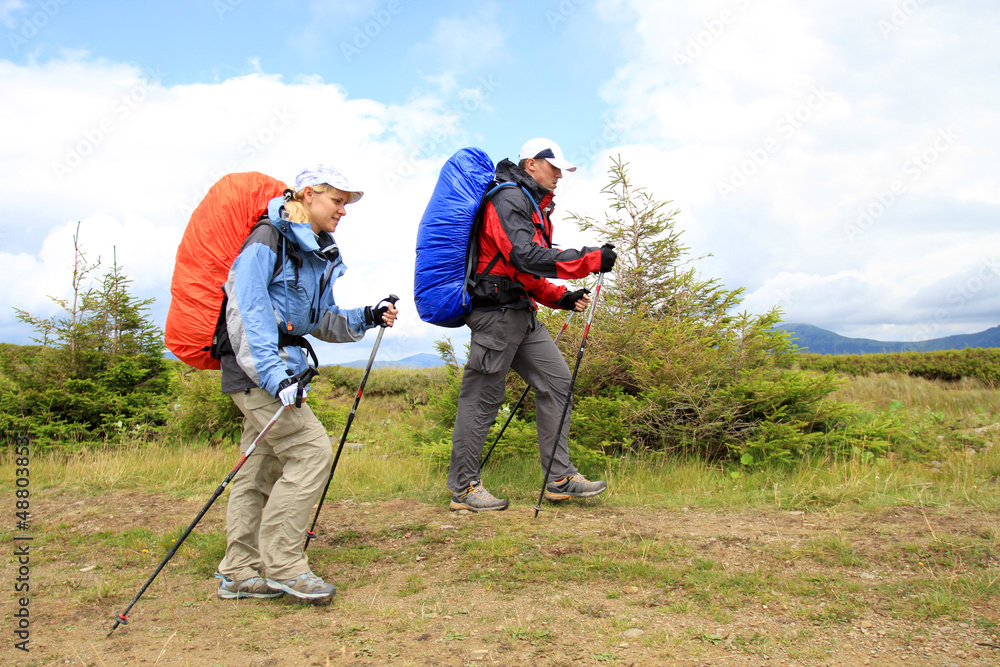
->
<box><xmin>7</xmin><ymin>492</ymin><xmax>1000</xmax><ymax>667</ymax></box>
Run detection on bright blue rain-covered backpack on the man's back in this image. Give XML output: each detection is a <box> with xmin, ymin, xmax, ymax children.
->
<box><xmin>413</xmin><ymin>148</ymin><xmax>541</xmax><ymax>327</ymax></box>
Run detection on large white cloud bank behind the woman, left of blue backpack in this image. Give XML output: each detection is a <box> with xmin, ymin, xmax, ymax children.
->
<box><xmin>0</xmin><ymin>57</ymin><xmax>468</xmax><ymax>363</ymax></box>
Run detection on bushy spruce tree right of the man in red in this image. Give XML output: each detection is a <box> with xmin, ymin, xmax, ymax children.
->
<box><xmin>564</xmin><ymin>158</ymin><xmax>848</xmax><ymax>460</ymax></box>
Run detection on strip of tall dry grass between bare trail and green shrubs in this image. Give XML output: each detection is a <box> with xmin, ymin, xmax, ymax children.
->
<box><xmin>13</xmin><ymin>376</ymin><xmax>1000</xmax><ymax>510</ymax></box>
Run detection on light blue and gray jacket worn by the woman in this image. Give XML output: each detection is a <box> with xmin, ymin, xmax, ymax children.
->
<box><xmin>220</xmin><ymin>197</ymin><xmax>375</xmax><ymax>396</ymax></box>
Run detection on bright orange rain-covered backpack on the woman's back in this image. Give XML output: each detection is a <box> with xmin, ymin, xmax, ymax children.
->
<box><xmin>163</xmin><ymin>171</ymin><xmax>288</xmax><ymax>370</ymax></box>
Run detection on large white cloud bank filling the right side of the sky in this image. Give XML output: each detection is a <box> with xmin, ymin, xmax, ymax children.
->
<box><xmin>603</xmin><ymin>0</ymin><xmax>1000</xmax><ymax>342</ymax></box>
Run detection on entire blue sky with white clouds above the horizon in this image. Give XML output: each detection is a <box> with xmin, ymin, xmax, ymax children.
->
<box><xmin>0</xmin><ymin>0</ymin><xmax>1000</xmax><ymax>363</ymax></box>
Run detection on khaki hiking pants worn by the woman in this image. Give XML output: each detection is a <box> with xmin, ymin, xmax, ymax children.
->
<box><xmin>219</xmin><ymin>388</ymin><xmax>333</xmax><ymax>581</ymax></box>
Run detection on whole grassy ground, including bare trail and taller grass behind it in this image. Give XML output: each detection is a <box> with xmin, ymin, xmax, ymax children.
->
<box><xmin>0</xmin><ymin>377</ymin><xmax>1000</xmax><ymax>665</ymax></box>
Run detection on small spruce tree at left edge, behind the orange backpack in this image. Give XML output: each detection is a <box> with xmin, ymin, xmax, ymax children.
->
<box><xmin>0</xmin><ymin>225</ymin><xmax>169</xmax><ymax>444</ymax></box>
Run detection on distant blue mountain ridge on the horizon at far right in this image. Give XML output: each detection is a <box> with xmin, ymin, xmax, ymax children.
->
<box><xmin>775</xmin><ymin>322</ymin><xmax>1000</xmax><ymax>354</ymax></box>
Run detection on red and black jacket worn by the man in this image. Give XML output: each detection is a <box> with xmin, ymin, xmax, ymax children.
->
<box><xmin>472</xmin><ymin>160</ymin><xmax>601</xmax><ymax>308</ymax></box>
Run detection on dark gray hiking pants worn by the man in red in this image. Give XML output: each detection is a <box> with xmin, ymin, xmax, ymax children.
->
<box><xmin>448</xmin><ymin>308</ymin><xmax>577</xmax><ymax>491</ymax></box>
